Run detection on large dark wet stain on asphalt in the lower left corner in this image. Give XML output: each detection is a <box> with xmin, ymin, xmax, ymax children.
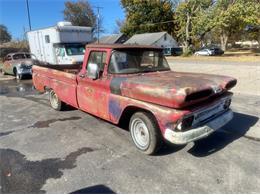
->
<box><xmin>0</xmin><ymin>147</ymin><xmax>96</xmax><ymax>194</ymax></box>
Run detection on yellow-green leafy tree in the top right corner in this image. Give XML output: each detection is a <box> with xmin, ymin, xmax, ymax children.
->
<box><xmin>211</xmin><ymin>0</ymin><xmax>260</xmax><ymax>51</ymax></box>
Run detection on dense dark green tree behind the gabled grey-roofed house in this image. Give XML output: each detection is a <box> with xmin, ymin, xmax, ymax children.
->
<box><xmin>121</xmin><ymin>0</ymin><xmax>175</xmax><ymax>36</ymax></box>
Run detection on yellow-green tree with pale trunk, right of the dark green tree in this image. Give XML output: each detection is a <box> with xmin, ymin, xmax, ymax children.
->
<box><xmin>176</xmin><ymin>0</ymin><xmax>212</xmax><ymax>53</ymax></box>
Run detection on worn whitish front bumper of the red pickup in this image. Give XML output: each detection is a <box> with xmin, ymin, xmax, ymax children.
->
<box><xmin>164</xmin><ymin>110</ymin><xmax>233</xmax><ymax>144</ymax></box>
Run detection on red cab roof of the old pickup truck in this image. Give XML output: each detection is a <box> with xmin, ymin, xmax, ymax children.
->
<box><xmin>86</xmin><ymin>44</ymin><xmax>163</xmax><ymax>50</ymax></box>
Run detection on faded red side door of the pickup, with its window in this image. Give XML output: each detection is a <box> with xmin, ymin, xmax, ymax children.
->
<box><xmin>77</xmin><ymin>51</ymin><xmax>110</xmax><ymax>119</ymax></box>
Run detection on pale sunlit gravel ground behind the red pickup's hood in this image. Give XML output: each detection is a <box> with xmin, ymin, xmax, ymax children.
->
<box><xmin>168</xmin><ymin>57</ymin><xmax>260</xmax><ymax>96</ymax></box>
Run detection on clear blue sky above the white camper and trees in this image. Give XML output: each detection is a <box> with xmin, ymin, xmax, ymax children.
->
<box><xmin>0</xmin><ymin>0</ymin><xmax>124</xmax><ymax>39</ymax></box>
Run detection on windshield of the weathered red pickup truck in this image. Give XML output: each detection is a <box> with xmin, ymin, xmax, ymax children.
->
<box><xmin>109</xmin><ymin>50</ymin><xmax>170</xmax><ymax>74</ymax></box>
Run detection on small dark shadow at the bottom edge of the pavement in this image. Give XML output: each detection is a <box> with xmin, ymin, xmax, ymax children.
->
<box><xmin>70</xmin><ymin>185</ymin><xmax>115</xmax><ymax>194</ymax></box>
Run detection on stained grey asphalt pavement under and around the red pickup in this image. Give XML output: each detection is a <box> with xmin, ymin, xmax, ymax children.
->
<box><xmin>0</xmin><ymin>75</ymin><xmax>260</xmax><ymax>193</ymax></box>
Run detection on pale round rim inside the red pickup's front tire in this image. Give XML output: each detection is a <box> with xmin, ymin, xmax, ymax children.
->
<box><xmin>131</xmin><ymin>118</ymin><xmax>150</xmax><ymax>150</ymax></box>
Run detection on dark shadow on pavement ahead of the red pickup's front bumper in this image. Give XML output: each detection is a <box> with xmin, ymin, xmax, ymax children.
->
<box><xmin>188</xmin><ymin>112</ymin><xmax>259</xmax><ymax>157</ymax></box>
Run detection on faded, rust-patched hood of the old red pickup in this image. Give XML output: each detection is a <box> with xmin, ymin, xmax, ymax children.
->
<box><xmin>110</xmin><ymin>71</ymin><xmax>237</xmax><ymax>108</ymax></box>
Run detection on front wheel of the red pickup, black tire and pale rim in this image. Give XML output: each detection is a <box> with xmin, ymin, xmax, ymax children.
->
<box><xmin>129</xmin><ymin>112</ymin><xmax>162</xmax><ymax>155</ymax></box>
